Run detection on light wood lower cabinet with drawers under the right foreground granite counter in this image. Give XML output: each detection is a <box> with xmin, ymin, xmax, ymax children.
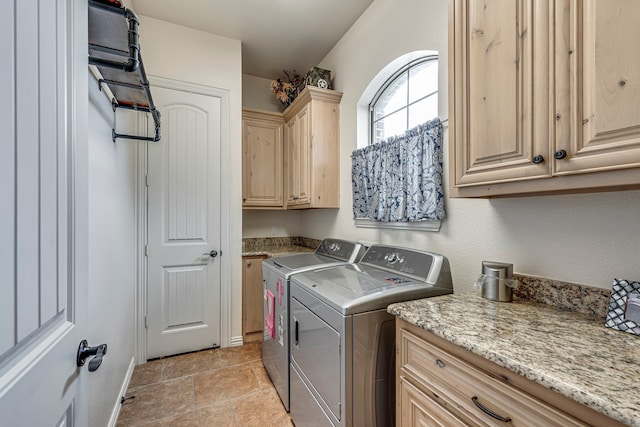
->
<box><xmin>396</xmin><ymin>320</ymin><xmax>621</xmax><ymax>427</ymax></box>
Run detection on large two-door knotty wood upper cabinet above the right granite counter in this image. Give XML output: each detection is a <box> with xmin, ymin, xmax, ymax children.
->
<box><xmin>449</xmin><ymin>0</ymin><xmax>640</xmax><ymax>197</ymax></box>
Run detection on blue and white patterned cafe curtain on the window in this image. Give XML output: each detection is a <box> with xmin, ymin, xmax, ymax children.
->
<box><xmin>351</xmin><ymin>118</ymin><xmax>446</xmax><ymax>222</ymax></box>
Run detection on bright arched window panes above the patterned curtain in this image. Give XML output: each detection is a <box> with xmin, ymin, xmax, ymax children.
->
<box><xmin>369</xmin><ymin>55</ymin><xmax>438</xmax><ymax>144</ymax></box>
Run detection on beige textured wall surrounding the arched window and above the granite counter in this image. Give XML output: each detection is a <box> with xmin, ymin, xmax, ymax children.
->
<box><xmin>241</xmin><ymin>0</ymin><xmax>640</xmax><ymax>292</ymax></box>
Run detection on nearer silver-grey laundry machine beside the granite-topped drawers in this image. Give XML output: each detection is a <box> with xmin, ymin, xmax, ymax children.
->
<box><xmin>290</xmin><ymin>245</ymin><xmax>453</xmax><ymax>427</ymax></box>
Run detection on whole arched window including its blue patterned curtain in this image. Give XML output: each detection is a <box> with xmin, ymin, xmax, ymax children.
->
<box><xmin>351</xmin><ymin>54</ymin><xmax>446</xmax><ymax>231</ymax></box>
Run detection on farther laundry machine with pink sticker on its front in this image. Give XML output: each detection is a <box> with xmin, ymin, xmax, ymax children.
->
<box><xmin>262</xmin><ymin>238</ymin><xmax>366</xmax><ymax>411</ymax></box>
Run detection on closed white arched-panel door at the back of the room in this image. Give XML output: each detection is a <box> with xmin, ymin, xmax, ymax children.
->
<box><xmin>147</xmin><ymin>85</ymin><xmax>221</xmax><ymax>359</ymax></box>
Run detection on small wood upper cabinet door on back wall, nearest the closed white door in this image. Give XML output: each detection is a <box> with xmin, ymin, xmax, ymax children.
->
<box><xmin>242</xmin><ymin>109</ymin><xmax>284</xmax><ymax>209</ymax></box>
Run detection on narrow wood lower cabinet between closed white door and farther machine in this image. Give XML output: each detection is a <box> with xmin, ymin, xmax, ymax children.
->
<box><xmin>242</xmin><ymin>256</ymin><xmax>267</xmax><ymax>342</ymax></box>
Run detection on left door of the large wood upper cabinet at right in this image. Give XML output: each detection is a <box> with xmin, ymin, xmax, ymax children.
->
<box><xmin>449</xmin><ymin>0</ymin><xmax>551</xmax><ymax>187</ymax></box>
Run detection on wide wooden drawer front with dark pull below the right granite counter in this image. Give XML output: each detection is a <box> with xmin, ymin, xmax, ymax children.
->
<box><xmin>399</xmin><ymin>329</ymin><xmax>587</xmax><ymax>426</ymax></box>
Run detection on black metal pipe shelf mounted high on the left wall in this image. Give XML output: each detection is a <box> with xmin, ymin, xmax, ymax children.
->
<box><xmin>89</xmin><ymin>0</ymin><xmax>160</xmax><ymax>142</ymax></box>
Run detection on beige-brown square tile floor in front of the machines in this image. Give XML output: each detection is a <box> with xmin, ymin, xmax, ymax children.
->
<box><xmin>117</xmin><ymin>342</ymin><xmax>293</xmax><ymax>427</ymax></box>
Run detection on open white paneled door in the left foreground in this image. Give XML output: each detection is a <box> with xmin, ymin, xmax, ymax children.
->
<box><xmin>0</xmin><ymin>0</ymin><xmax>88</xmax><ymax>426</ymax></box>
